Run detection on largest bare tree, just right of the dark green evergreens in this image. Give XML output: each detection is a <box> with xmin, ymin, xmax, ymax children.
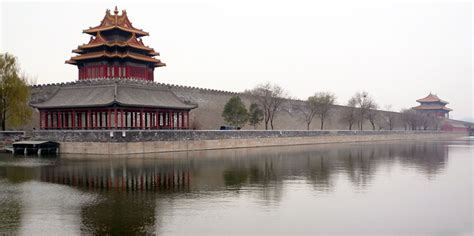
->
<box><xmin>249</xmin><ymin>82</ymin><xmax>287</xmax><ymax>130</ymax></box>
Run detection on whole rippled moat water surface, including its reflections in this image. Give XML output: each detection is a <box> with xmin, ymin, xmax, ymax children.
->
<box><xmin>0</xmin><ymin>138</ymin><xmax>474</xmax><ymax>235</ymax></box>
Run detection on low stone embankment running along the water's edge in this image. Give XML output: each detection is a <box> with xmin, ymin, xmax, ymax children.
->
<box><xmin>32</xmin><ymin>130</ymin><xmax>467</xmax><ymax>155</ymax></box>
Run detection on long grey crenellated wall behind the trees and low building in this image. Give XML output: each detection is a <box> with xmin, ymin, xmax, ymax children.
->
<box><xmin>27</xmin><ymin>79</ymin><xmax>404</xmax><ymax>130</ymax></box>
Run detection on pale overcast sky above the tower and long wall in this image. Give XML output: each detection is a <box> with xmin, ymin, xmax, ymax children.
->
<box><xmin>0</xmin><ymin>0</ymin><xmax>474</xmax><ymax>119</ymax></box>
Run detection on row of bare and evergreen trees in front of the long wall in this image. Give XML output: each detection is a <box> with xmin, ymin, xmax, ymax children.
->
<box><xmin>222</xmin><ymin>82</ymin><xmax>440</xmax><ymax>130</ymax></box>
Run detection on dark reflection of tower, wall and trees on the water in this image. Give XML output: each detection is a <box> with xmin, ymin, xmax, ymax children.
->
<box><xmin>0</xmin><ymin>142</ymin><xmax>468</xmax><ymax>234</ymax></box>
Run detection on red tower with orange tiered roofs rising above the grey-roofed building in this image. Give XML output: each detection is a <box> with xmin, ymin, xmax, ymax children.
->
<box><xmin>66</xmin><ymin>7</ymin><xmax>166</xmax><ymax>81</ymax></box>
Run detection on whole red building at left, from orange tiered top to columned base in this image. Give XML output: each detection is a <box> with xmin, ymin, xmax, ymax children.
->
<box><xmin>31</xmin><ymin>7</ymin><xmax>197</xmax><ymax>130</ymax></box>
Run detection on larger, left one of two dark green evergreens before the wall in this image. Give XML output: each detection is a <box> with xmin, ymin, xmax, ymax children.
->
<box><xmin>222</xmin><ymin>96</ymin><xmax>248</xmax><ymax>127</ymax></box>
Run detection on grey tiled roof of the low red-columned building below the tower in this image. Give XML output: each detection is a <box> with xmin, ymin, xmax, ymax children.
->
<box><xmin>31</xmin><ymin>80</ymin><xmax>197</xmax><ymax>110</ymax></box>
